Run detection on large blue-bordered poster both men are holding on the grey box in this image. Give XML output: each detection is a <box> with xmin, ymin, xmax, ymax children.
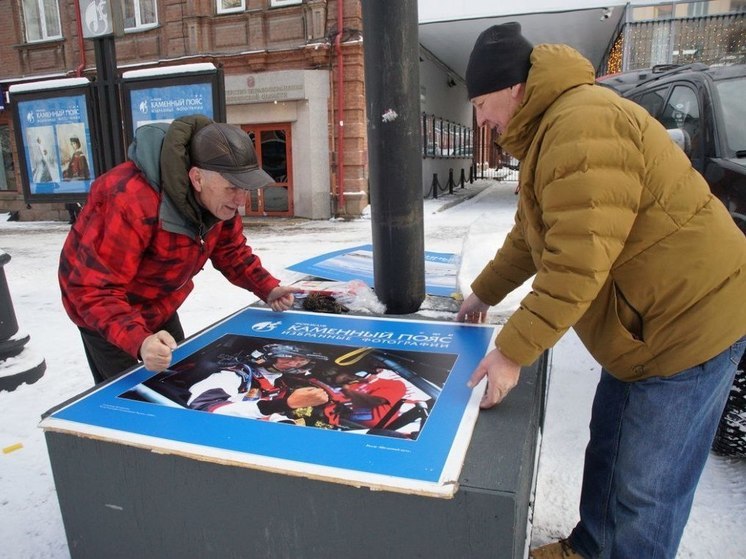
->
<box><xmin>42</xmin><ymin>308</ymin><xmax>494</xmax><ymax>497</ymax></box>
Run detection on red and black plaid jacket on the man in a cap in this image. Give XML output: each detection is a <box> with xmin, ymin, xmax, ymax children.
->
<box><xmin>59</xmin><ymin>161</ymin><xmax>280</xmax><ymax>357</ymax></box>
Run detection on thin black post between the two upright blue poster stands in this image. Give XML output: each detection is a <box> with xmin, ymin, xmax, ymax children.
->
<box><xmin>93</xmin><ymin>36</ymin><xmax>126</xmax><ymax>171</ymax></box>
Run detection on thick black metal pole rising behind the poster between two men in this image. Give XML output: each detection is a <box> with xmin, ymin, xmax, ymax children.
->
<box><xmin>362</xmin><ymin>0</ymin><xmax>425</xmax><ymax>314</ymax></box>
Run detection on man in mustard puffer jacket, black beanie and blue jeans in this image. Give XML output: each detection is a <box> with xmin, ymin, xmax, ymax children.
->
<box><xmin>458</xmin><ymin>23</ymin><xmax>746</xmax><ymax>559</ymax></box>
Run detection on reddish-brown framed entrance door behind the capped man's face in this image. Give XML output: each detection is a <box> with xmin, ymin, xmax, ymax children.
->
<box><xmin>241</xmin><ymin>123</ymin><xmax>293</xmax><ymax>217</ymax></box>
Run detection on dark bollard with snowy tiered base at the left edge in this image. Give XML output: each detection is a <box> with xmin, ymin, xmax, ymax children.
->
<box><xmin>0</xmin><ymin>249</ymin><xmax>47</xmax><ymax>392</ymax></box>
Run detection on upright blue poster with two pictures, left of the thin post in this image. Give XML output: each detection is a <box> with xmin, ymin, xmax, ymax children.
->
<box><xmin>18</xmin><ymin>94</ymin><xmax>95</xmax><ymax>195</ymax></box>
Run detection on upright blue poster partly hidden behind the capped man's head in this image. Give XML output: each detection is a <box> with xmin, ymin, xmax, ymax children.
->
<box><xmin>130</xmin><ymin>83</ymin><xmax>215</xmax><ymax>132</ymax></box>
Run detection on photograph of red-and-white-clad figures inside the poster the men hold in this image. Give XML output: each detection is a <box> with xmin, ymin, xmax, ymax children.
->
<box><xmin>121</xmin><ymin>334</ymin><xmax>456</xmax><ymax>439</ymax></box>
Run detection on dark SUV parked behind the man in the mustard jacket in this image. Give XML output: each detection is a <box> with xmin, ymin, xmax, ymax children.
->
<box><xmin>597</xmin><ymin>64</ymin><xmax>746</xmax><ymax>458</ymax></box>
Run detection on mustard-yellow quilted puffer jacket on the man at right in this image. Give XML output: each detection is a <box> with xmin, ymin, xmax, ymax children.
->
<box><xmin>472</xmin><ymin>41</ymin><xmax>746</xmax><ymax>381</ymax></box>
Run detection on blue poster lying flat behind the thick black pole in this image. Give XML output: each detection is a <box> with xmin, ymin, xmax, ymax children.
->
<box><xmin>288</xmin><ymin>245</ymin><xmax>459</xmax><ymax>297</ymax></box>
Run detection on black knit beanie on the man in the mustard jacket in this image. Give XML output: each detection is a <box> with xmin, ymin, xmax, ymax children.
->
<box><xmin>466</xmin><ymin>21</ymin><xmax>534</xmax><ymax>99</ymax></box>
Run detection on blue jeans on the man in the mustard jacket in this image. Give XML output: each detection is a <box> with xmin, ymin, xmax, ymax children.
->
<box><xmin>570</xmin><ymin>337</ymin><xmax>746</xmax><ymax>559</ymax></box>
